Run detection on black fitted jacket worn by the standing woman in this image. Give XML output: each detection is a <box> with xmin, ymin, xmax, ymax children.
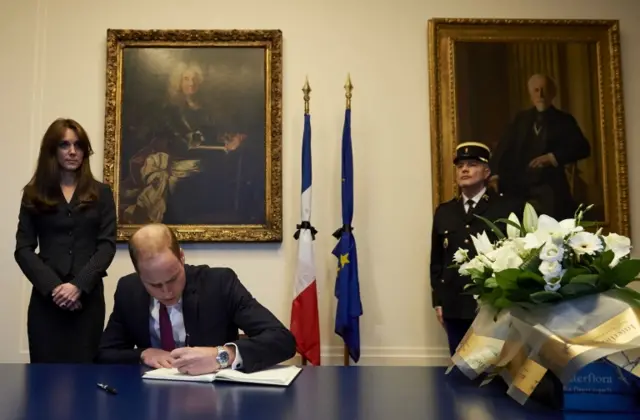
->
<box><xmin>14</xmin><ymin>181</ymin><xmax>116</xmax><ymax>296</ymax></box>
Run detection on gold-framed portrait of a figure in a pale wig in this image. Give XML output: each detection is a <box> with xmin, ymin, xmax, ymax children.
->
<box><xmin>104</xmin><ymin>30</ymin><xmax>282</xmax><ymax>242</ymax></box>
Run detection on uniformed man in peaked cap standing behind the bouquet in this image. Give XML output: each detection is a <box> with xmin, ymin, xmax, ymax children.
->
<box><xmin>430</xmin><ymin>142</ymin><xmax>524</xmax><ymax>355</ymax></box>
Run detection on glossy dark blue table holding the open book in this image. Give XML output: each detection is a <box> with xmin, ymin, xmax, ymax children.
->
<box><xmin>0</xmin><ymin>364</ymin><xmax>632</xmax><ymax>420</ymax></box>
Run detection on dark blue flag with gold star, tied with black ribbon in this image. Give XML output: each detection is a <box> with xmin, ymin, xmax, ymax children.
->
<box><xmin>333</xmin><ymin>108</ymin><xmax>362</xmax><ymax>363</ymax></box>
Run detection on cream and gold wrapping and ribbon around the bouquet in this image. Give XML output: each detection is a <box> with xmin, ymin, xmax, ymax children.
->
<box><xmin>452</xmin><ymin>289</ymin><xmax>640</xmax><ymax>404</ymax></box>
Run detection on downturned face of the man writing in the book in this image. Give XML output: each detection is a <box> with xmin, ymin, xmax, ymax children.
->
<box><xmin>138</xmin><ymin>249</ymin><xmax>186</xmax><ymax>306</ymax></box>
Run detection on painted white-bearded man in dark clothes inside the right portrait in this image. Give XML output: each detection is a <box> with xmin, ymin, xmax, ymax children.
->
<box><xmin>490</xmin><ymin>74</ymin><xmax>591</xmax><ymax>220</ymax></box>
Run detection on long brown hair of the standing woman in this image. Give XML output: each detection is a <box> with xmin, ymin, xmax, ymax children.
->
<box><xmin>24</xmin><ymin>118</ymin><xmax>98</xmax><ymax>210</ymax></box>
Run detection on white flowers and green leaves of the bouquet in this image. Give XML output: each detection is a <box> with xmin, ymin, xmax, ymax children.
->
<box><xmin>454</xmin><ymin>203</ymin><xmax>640</xmax><ymax>310</ymax></box>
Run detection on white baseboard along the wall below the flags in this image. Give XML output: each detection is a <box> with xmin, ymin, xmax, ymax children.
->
<box><xmin>292</xmin><ymin>346</ymin><xmax>450</xmax><ymax>366</ymax></box>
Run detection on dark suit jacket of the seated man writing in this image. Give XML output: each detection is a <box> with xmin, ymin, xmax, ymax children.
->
<box><xmin>97</xmin><ymin>264</ymin><xmax>296</xmax><ymax>372</ymax></box>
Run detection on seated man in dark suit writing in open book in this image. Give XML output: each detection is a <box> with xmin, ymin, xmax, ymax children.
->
<box><xmin>98</xmin><ymin>224</ymin><xmax>296</xmax><ymax>375</ymax></box>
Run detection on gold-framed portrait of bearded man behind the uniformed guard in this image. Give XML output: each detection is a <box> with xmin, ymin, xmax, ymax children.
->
<box><xmin>429</xmin><ymin>19</ymin><xmax>629</xmax><ymax>235</ymax></box>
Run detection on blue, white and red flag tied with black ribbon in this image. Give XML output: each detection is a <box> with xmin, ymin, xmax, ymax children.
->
<box><xmin>291</xmin><ymin>113</ymin><xmax>320</xmax><ymax>366</ymax></box>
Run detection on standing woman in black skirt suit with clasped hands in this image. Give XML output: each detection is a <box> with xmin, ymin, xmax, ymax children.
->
<box><xmin>14</xmin><ymin>119</ymin><xmax>116</xmax><ymax>363</ymax></box>
